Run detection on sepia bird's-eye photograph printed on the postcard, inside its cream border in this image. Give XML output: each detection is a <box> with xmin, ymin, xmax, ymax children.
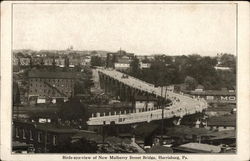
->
<box><xmin>1</xmin><ymin>1</ymin><xmax>249</xmax><ymax>160</ymax></box>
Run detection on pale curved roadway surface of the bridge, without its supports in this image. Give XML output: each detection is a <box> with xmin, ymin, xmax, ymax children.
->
<box><xmin>87</xmin><ymin>69</ymin><xmax>207</xmax><ymax>125</ymax></box>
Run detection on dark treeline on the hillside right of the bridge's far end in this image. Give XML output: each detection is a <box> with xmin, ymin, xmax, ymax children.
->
<box><xmin>128</xmin><ymin>54</ymin><xmax>236</xmax><ymax>90</ymax></box>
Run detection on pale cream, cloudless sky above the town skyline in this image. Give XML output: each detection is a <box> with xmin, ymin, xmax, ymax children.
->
<box><xmin>13</xmin><ymin>3</ymin><xmax>236</xmax><ymax>56</ymax></box>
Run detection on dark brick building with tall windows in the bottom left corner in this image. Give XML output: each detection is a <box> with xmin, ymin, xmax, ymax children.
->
<box><xmin>12</xmin><ymin>120</ymin><xmax>79</xmax><ymax>153</ymax></box>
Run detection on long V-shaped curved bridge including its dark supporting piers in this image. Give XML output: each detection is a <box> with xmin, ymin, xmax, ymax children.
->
<box><xmin>87</xmin><ymin>69</ymin><xmax>208</xmax><ymax>125</ymax></box>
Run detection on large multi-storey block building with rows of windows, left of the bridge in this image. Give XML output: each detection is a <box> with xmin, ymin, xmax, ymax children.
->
<box><xmin>28</xmin><ymin>71</ymin><xmax>81</xmax><ymax>101</ymax></box>
